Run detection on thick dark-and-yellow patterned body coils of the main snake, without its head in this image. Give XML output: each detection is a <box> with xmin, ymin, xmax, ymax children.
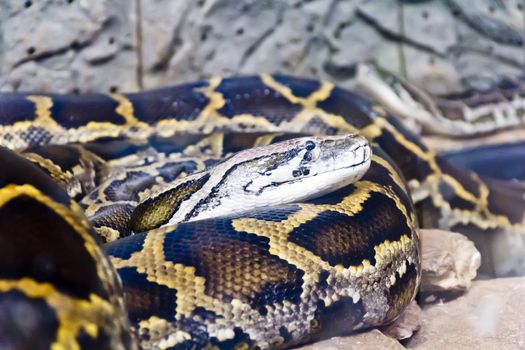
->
<box><xmin>0</xmin><ymin>75</ymin><xmax>525</xmax><ymax>349</ymax></box>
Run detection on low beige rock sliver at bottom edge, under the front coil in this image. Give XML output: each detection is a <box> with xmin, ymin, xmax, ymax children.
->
<box><xmin>297</xmin><ymin>329</ymin><xmax>404</xmax><ymax>350</ymax></box>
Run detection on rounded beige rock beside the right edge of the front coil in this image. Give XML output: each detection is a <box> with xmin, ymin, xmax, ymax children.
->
<box><xmin>420</xmin><ymin>229</ymin><xmax>481</xmax><ymax>293</ymax></box>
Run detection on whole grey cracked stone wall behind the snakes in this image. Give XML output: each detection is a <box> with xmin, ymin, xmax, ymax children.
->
<box><xmin>0</xmin><ymin>0</ymin><xmax>525</xmax><ymax>93</ymax></box>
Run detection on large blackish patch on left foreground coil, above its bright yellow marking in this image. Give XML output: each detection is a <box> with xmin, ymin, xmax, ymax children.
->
<box><xmin>0</xmin><ymin>195</ymin><xmax>107</xmax><ymax>299</ymax></box>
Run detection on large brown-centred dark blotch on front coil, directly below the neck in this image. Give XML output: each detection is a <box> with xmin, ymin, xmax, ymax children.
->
<box><xmin>164</xmin><ymin>218</ymin><xmax>303</xmax><ymax>312</ymax></box>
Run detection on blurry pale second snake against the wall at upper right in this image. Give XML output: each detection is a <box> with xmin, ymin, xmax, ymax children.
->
<box><xmin>357</xmin><ymin>64</ymin><xmax>525</xmax><ymax>143</ymax></box>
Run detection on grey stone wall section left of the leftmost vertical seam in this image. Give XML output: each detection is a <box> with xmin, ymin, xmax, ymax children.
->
<box><xmin>0</xmin><ymin>0</ymin><xmax>138</xmax><ymax>93</ymax></box>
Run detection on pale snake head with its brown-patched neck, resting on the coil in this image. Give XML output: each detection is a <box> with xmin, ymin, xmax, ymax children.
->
<box><xmin>131</xmin><ymin>135</ymin><xmax>372</xmax><ymax>232</ymax></box>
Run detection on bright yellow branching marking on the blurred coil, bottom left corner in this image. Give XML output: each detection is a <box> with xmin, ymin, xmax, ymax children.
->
<box><xmin>0</xmin><ymin>278</ymin><xmax>116</xmax><ymax>350</ymax></box>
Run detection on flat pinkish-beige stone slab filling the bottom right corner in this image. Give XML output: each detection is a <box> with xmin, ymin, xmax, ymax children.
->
<box><xmin>407</xmin><ymin>277</ymin><xmax>525</xmax><ymax>349</ymax></box>
